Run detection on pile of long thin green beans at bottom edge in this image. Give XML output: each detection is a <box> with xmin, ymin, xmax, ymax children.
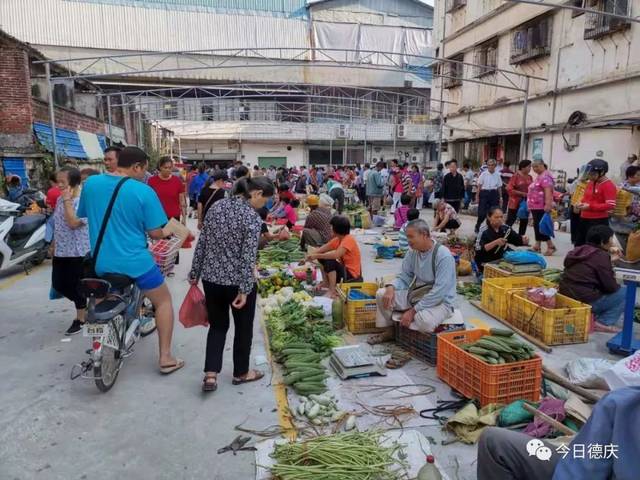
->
<box><xmin>271</xmin><ymin>431</ymin><xmax>406</xmax><ymax>480</ymax></box>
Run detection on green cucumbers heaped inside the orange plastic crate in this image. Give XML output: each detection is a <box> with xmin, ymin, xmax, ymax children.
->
<box><xmin>460</xmin><ymin>328</ymin><xmax>536</xmax><ymax>365</ymax></box>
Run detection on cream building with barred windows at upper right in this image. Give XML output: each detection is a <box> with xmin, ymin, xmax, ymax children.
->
<box><xmin>432</xmin><ymin>0</ymin><xmax>640</xmax><ymax>177</ymax></box>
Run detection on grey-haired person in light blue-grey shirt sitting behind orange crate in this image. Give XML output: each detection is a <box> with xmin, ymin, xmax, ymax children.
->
<box><xmin>368</xmin><ymin>220</ymin><xmax>464</xmax><ymax>344</ymax></box>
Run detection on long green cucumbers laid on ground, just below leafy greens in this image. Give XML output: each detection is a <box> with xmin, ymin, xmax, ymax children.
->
<box><xmin>279</xmin><ymin>343</ymin><xmax>329</xmax><ymax>396</ymax></box>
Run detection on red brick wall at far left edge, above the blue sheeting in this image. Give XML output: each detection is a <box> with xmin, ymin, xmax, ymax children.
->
<box><xmin>0</xmin><ymin>35</ymin><xmax>31</xmax><ymax>135</ymax></box>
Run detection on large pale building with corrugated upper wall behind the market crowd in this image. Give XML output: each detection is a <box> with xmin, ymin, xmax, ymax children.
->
<box><xmin>0</xmin><ymin>0</ymin><xmax>433</xmax><ymax>169</ymax></box>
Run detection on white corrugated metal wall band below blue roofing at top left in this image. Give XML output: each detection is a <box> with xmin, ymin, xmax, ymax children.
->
<box><xmin>0</xmin><ymin>0</ymin><xmax>309</xmax><ymax>51</ymax></box>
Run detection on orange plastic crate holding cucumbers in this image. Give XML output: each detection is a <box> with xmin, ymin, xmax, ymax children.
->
<box><xmin>437</xmin><ymin>329</ymin><xmax>542</xmax><ymax>406</ymax></box>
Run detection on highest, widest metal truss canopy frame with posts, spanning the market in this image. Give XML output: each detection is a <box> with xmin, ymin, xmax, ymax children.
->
<box><xmin>34</xmin><ymin>47</ymin><xmax>546</xmax><ymax>163</ymax></box>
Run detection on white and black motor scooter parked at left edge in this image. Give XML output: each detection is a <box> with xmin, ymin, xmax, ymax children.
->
<box><xmin>0</xmin><ymin>198</ymin><xmax>49</xmax><ymax>272</ymax></box>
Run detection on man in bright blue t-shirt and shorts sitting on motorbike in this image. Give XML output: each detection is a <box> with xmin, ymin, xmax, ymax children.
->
<box><xmin>78</xmin><ymin>147</ymin><xmax>184</xmax><ymax>373</ymax></box>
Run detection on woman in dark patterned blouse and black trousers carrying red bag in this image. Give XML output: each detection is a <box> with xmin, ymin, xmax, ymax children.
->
<box><xmin>189</xmin><ymin>177</ymin><xmax>275</xmax><ymax>392</ymax></box>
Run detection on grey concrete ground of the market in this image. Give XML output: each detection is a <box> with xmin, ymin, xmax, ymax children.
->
<box><xmin>0</xmin><ymin>210</ymin><xmax>632</xmax><ymax>480</ymax></box>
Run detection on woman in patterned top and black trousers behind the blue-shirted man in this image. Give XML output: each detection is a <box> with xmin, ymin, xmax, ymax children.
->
<box><xmin>51</xmin><ymin>167</ymin><xmax>90</xmax><ymax>336</ymax></box>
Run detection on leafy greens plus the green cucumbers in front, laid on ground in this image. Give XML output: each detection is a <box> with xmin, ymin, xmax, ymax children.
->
<box><xmin>266</xmin><ymin>300</ymin><xmax>342</xmax><ymax>395</ymax></box>
